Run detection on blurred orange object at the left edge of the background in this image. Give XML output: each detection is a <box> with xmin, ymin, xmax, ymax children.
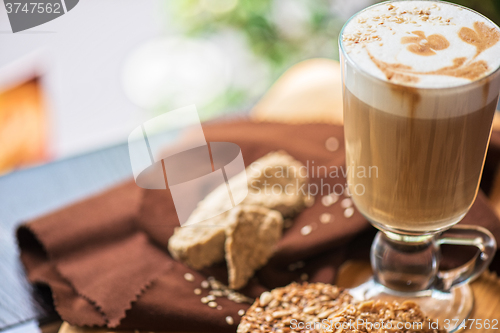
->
<box><xmin>0</xmin><ymin>77</ymin><xmax>48</xmax><ymax>174</ymax></box>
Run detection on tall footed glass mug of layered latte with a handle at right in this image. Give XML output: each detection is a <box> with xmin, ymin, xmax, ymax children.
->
<box><xmin>339</xmin><ymin>1</ymin><xmax>500</xmax><ymax>331</ymax></box>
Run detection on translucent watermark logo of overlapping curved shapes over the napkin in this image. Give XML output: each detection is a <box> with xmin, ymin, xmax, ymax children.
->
<box><xmin>128</xmin><ymin>105</ymin><xmax>248</xmax><ymax>226</ymax></box>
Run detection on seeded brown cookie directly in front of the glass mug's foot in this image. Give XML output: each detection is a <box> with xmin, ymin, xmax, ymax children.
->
<box><xmin>320</xmin><ymin>300</ymin><xmax>446</xmax><ymax>333</ymax></box>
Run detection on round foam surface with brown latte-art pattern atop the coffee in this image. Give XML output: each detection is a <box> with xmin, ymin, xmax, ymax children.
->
<box><xmin>342</xmin><ymin>1</ymin><xmax>500</xmax><ymax>87</ymax></box>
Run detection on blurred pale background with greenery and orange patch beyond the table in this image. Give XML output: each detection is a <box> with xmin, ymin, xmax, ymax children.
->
<box><xmin>0</xmin><ymin>0</ymin><xmax>500</xmax><ymax>174</ymax></box>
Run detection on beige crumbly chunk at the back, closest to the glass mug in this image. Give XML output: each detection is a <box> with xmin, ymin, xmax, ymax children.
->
<box><xmin>243</xmin><ymin>150</ymin><xmax>312</xmax><ymax>217</ymax></box>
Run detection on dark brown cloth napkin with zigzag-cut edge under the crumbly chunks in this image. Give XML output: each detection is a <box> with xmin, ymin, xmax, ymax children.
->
<box><xmin>17</xmin><ymin>120</ymin><xmax>500</xmax><ymax>332</ymax></box>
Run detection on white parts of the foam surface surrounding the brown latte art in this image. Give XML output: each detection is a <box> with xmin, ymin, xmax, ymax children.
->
<box><xmin>342</xmin><ymin>1</ymin><xmax>500</xmax><ymax>88</ymax></box>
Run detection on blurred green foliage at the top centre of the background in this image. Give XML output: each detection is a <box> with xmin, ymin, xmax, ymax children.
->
<box><xmin>168</xmin><ymin>0</ymin><xmax>343</xmax><ymax>71</ymax></box>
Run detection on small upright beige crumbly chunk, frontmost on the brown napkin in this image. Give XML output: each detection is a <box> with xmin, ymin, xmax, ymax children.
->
<box><xmin>225</xmin><ymin>206</ymin><xmax>283</xmax><ymax>289</ymax></box>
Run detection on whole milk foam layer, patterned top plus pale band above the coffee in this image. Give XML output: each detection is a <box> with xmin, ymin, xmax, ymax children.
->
<box><xmin>340</xmin><ymin>1</ymin><xmax>500</xmax><ymax>118</ymax></box>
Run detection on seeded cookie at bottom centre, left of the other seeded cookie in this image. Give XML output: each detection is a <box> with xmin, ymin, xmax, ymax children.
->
<box><xmin>237</xmin><ymin>282</ymin><xmax>353</xmax><ymax>333</ymax></box>
